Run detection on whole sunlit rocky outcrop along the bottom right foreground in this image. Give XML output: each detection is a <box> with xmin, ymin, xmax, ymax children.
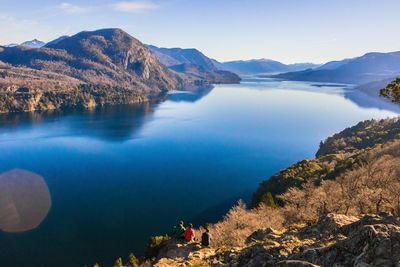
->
<box><xmin>154</xmin><ymin>213</ymin><xmax>400</xmax><ymax>267</ymax></box>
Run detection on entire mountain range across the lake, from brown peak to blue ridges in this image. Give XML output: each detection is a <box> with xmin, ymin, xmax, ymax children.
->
<box><xmin>0</xmin><ymin>29</ymin><xmax>400</xmax><ymax>112</ymax></box>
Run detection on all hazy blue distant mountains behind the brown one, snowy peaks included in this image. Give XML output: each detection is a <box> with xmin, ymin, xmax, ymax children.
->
<box><xmin>5</xmin><ymin>36</ymin><xmax>400</xmax><ymax>86</ymax></box>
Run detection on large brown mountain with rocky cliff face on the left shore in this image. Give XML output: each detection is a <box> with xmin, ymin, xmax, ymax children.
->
<box><xmin>0</xmin><ymin>29</ymin><xmax>182</xmax><ymax>112</ymax></box>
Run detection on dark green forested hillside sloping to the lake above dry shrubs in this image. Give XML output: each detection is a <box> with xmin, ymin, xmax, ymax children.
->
<box><xmin>252</xmin><ymin>118</ymin><xmax>400</xmax><ymax>206</ymax></box>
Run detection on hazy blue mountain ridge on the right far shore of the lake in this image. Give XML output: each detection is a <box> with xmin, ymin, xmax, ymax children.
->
<box><xmin>273</xmin><ymin>52</ymin><xmax>400</xmax><ymax>84</ymax></box>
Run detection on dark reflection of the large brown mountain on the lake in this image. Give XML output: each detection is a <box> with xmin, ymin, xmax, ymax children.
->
<box><xmin>0</xmin><ymin>103</ymin><xmax>155</xmax><ymax>142</ymax></box>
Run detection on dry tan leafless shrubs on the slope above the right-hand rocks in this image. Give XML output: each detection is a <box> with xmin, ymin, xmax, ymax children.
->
<box><xmin>280</xmin><ymin>140</ymin><xmax>400</xmax><ymax>223</ymax></box>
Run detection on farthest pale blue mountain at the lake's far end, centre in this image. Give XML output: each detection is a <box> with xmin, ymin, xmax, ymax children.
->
<box><xmin>215</xmin><ymin>59</ymin><xmax>318</xmax><ymax>75</ymax></box>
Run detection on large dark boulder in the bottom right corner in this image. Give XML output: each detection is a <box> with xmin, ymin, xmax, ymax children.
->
<box><xmin>290</xmin><ymin>213</ymin><xmax>400</xmax><ymax>267</ymax></box>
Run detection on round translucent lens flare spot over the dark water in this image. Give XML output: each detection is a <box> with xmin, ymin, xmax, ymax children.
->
<box><xmin>0</xmin><ymin>169</ymin><xmax>51</xmax><ymax>233</ymax></box>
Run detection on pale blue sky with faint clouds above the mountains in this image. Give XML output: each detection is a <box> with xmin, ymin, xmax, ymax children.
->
<box><xmin>0</xmin><ymin>0</ymin><xmax>400</xmax><ymax>63</ymax></box>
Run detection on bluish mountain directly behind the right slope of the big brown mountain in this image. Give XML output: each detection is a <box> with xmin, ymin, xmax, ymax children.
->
<box><xmin>148</xmin><ymin>45</ymin><xmax>240</xmax><ymax>83</ymax></box>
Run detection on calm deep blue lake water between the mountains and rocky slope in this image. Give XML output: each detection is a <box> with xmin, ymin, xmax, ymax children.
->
<box><xmin>0</xmin><ymin>79</ymin><xmax>400</xmax><ymax>267</ymax></box>
